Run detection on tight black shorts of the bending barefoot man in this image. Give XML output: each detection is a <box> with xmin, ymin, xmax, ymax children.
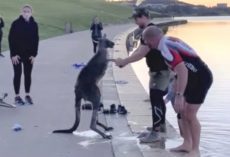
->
<box><xmin>184</xmin><ymin>67</ymin><xmax>213</xmax><ymax>105</ymax></box>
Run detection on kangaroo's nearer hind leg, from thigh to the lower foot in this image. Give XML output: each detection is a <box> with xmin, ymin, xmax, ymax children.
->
<box><xmin>88</xmin><ymin>86</ymin><xmax>112</xmax><ymax>139</ymax></box>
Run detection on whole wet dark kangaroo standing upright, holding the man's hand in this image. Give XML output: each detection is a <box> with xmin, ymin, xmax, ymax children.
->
<box><xmin>53</xmin><ymin>35</ymin><xmax>114</xmax><ymax>139</ymax></box>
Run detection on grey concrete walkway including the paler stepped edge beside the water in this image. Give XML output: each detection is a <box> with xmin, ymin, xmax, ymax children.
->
<box><xmin>0</xmin><ymin>21</ymin><xmax>183</xmax><ymax>157</ymax></box>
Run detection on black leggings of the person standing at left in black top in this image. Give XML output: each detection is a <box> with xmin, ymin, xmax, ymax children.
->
<box><xmin>13</xmin><ymin>59</ymin><xmax>33</xmax><ymax>95</ymax></box>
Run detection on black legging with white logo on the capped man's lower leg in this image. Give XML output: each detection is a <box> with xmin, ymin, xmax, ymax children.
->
<box><xmin>150</xmin><ymin>89</ymin><xmax>166</xmax><ymax>130</ymax></box>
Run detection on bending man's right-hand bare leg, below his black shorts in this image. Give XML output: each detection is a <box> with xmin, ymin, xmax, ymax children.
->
<box><xmin>184</xmin><ymin>104</ymin><xmax>201</xmax><ymax>157</ymax></box>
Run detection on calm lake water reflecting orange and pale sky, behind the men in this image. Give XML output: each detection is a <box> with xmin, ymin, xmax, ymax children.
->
<box><xmin>132</xmin><ymin>17</ymin><xmax>230</xmax><ymax>157</ymax></box>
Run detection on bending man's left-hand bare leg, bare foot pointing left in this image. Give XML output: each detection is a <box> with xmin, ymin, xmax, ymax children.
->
<box><xmin>170</xmin><ymin>104</ymin><xmax>193</xmax><ymax>152</ymax></box>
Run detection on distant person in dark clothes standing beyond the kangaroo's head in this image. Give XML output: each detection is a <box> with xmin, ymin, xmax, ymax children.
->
<box><xmin>90</xmin><ymin>16</ymin><xmax>103</xmax><ymax>53</ymax></box>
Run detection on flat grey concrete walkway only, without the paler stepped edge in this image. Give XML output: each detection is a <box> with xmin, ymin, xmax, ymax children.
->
<box><xmin>0</xmin><ymin>25</ymin><xmax>131</xmax><ymax>157</ymax></box>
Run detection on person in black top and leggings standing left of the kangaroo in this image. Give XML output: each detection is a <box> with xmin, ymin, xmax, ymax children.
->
<box><xmin>9</xmin><ymin>5</ymin><xmax>39</xmax><ymax>105</ymax></box>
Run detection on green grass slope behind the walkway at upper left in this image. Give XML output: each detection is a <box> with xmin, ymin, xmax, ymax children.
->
<box><xmin>0</xmin><ymin>0</ymin><xmax>132</xmax><ymax>50</ymax></box>
